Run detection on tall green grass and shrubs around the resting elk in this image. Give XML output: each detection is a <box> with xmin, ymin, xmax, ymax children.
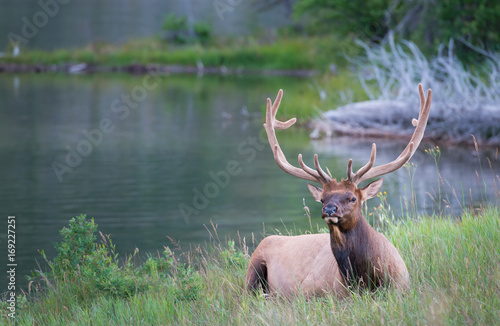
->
<box><xmin>2</xmin><ymin>208</ymin><xmax>500</xmax><ymax>325</ymax></box>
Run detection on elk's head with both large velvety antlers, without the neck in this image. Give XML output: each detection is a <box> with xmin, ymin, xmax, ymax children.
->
<box><xmin>264</xmin><ymin>84</ymin><xmax>432</xmax><ymax>241</ymax></box>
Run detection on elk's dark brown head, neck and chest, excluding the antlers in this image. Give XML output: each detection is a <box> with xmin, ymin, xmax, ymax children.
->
<box><xmin>309</xmin><ymin>179</ymin><xmax>409</xmax><ymax>291</ymax></box>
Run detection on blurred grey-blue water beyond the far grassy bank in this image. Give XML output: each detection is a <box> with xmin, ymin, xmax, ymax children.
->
<box><xmin>0</xmin><ymin>0</ymin><xmax>290</xmax><ymax>52</ymax></box>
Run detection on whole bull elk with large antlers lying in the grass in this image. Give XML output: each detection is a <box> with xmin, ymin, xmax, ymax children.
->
<box><xmin>245</xmin><ymin>84</ymin><xmax>432</xmax><ymax>297</ymax></box>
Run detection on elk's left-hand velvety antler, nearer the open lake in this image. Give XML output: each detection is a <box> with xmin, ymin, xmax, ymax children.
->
<box><xmin>264</xmin><ymin>89</ymin><xmax>331</xmax><ymax>185</ymax></box>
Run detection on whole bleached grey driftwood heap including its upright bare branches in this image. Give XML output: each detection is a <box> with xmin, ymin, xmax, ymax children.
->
<box><xmin>313</xmin><ymin>33</ymin><xmax>500</xmax><ymax>146</ymax></box>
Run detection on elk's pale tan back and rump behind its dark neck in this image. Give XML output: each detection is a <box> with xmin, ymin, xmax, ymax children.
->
<box><xmin>245</xmin><ymin>233</ymin><xmax>347</xmax><ymax>298</ymax></box>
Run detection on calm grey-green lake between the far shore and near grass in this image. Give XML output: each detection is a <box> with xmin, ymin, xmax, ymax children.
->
<box><xmin>0</xmin><ymin>74</ymin><xmax>499</xmax><ymax>292</ymax></box>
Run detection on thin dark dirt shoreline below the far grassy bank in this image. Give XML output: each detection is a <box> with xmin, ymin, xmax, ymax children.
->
<box><xmin>0</xmin><ymin>62</ymin><xmax>318</xmax><ymax>77</ymax></box>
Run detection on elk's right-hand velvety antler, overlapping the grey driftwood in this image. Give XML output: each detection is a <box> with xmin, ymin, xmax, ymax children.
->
<box><xmin>347</xmin><ymin>84</ymin><xmax>432</xmax><ymax>186</ymax></box>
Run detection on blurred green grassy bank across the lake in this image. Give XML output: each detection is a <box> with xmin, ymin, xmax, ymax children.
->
<box><xmin>0</xmin><ymin>37</ymin><xmax>348</xmax><ymax>70</ymax></box>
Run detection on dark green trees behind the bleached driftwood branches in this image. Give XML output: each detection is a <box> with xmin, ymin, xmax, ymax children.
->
<box><xmin>295</xmin><ymin>0</ymin><xmax>500</xmax><ymax>58</ymax></box>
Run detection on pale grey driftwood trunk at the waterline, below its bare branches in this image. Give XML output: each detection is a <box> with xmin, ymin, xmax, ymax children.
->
<box><xmin>313</xmin><ymin>96</ymin><xmax>500</xmax><ymax>145</ymax></box>
